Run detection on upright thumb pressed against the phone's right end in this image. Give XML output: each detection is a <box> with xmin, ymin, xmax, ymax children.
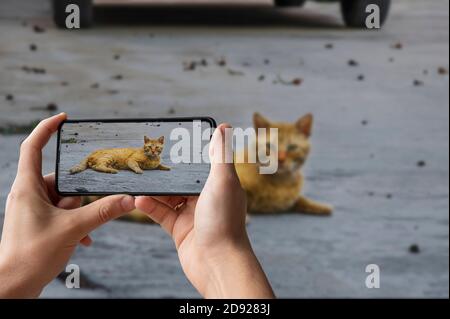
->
<box><xmin>209</xmin><ymin>124</ymin><xmax>238</xmax><ymax>184</ymax></box>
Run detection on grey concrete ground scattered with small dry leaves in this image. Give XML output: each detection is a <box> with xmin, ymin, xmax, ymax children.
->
<box><xmin>0</xmin><ymin>0</ymin><xmax>449</xmax><ymax>298</ymax></box>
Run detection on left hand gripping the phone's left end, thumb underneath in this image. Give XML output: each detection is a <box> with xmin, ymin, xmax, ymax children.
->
<box><xmin>0</xmin><ymin>113</ymin><xmax>135</xmax><ymax>298</ymax></box>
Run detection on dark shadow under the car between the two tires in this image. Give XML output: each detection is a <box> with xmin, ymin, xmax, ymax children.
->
<box><xmin>95</xmin><ymin>5</ymin><xmax>343</xmax><ymax>28</ymax></box>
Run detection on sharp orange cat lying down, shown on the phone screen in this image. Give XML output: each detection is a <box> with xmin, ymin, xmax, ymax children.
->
<box><xmin>70</xmin><ymin>136</ymin><xmax>170</xmax><ymax>174</ymax></box>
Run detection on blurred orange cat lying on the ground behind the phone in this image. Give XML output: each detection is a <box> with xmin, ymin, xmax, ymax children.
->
<box><xmin>235</xmin><ymin>113</ymin><xmax>332</xmax><ymax>215</ymax></box>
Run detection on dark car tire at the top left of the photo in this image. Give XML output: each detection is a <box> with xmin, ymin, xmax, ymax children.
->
<box><xmin>52</xmin><ymin>0</ymin><xmax>94</xmax><ymax>29</ymax></box>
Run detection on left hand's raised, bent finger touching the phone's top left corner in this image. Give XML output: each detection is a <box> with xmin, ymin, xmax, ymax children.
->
<box><xmin>18</xmin><ymin>113</ymin><xmax>67</xmax><ymax>178</ymax></box>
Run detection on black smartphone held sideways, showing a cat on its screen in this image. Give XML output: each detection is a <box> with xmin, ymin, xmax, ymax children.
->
<box><xmin>55</xmin><ymin>117</ymin><xmax>216</xmax><ymax>196</ymax></box>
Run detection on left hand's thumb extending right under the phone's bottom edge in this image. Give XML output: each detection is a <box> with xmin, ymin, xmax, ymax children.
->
<box><xmin>72</xmin><ymin>195</ymin><xmax>136</xmax><ymax>234</ymax></box>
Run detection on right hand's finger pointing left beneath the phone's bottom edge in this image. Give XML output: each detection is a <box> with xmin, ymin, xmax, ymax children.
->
<box><xmin>136</xmin><ymin>196</ymin><xmax>178</xmax><ymax>236</ymax></box>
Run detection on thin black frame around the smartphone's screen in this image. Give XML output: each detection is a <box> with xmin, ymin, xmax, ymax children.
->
<box><xmin>55</xmin><ymin>116</ymin><xmax>217</xmax><ymax>196</ymax></box>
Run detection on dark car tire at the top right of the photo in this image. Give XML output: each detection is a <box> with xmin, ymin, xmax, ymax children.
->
<box><xmin>341</xmin><ymin>0</ymin><xmax>391</xmax><ymax>28</ymax></box>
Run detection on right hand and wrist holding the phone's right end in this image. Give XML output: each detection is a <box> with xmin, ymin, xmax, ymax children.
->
<box><xmin>135</xmin><ymin>125</ymin><xmax>274</xmax><ymax>298</ymax></box>
